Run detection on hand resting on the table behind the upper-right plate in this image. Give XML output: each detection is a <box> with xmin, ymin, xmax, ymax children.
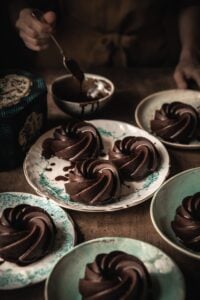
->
<box><xmin>174</xmin><ymin>57</ymin><xmax>200</xmax><ymax>89</ymax></box>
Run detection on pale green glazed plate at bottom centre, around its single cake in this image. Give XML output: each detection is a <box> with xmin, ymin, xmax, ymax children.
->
<box><xmin>45</xmin><ymin>237</ymin><xmax>185</xmax><ymax>300</ymax></box>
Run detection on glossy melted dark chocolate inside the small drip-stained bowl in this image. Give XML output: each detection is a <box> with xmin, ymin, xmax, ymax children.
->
<box><xmin>53</xmin><ymin>77</ymin><xmax>111</xmax><ymax>103</ymax></box>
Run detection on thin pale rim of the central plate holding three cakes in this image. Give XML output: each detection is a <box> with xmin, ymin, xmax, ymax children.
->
<box><xmin>23</xmin><ymin>119</ymin><xmax>171</xmax><ymax>213</ymax></box>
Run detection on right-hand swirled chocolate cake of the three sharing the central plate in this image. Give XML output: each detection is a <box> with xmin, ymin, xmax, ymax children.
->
<box><xmin>109</xmin><ymin>136</ymin><xmax>160</xmax><ymax>181</ymax></box>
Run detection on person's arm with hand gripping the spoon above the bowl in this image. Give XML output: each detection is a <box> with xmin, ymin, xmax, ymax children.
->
<box><xmin>10</xmin><ymin>0</ymin><xmax>58</xmax><ymax>51</ymax></box>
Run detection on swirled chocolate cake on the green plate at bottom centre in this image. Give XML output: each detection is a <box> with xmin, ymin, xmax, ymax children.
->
<box><xmin>79</xmin><ymin>251</ymin><xmax>151</xmax><ymax>300</ymax></box>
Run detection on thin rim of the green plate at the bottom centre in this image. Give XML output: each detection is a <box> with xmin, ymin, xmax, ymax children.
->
<box><xmin>44</xmin><ymin>236</ymin><xmax>186</xmax><ymax>300</ymax></box>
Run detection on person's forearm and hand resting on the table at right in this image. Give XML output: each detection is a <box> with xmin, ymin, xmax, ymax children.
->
<box><xmin>174</xmin><ymin>1</ymin><xmax>200</xmax><ymax>89</ymax></box>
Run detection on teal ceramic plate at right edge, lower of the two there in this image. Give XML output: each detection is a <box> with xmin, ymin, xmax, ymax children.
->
<box><xmin>150</xmin><ymin>168</ymin><xmax>200</xmax><ymax>259</ymax></box>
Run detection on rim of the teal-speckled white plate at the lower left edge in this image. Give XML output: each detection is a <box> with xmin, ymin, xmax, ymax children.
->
<box><xmin>0</xmin><ymin>191</ymin><xmax>77</xmax><ymax>291</ymax></box>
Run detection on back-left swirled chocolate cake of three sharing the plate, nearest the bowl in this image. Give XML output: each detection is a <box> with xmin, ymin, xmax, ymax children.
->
<box><xmin>42</xmin><ymin>120</ymin><xmax>103</xmax><ymax>162</ymax></box>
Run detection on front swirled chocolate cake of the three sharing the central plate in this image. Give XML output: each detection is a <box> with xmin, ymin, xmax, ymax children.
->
<box><xmin>65</xmin><ymin>159</ymin><xmax>121</xmax><ymax>205</ymax></box>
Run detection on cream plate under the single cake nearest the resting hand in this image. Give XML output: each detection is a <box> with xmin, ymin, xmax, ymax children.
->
<box><xmin>135</xmin><ymin>90</ymin><xmax>200</xmax><ymax>149</ymax></box>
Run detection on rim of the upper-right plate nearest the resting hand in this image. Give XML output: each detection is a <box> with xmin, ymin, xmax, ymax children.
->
<box><xmin>134</xmin><ymin>89</ymin><xmax>200</xmax><ymax>150</ymax></box>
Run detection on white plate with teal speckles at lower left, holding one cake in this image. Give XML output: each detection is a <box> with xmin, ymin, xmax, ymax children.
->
<box><xmin>0</xmin><ymin>193</ymin><xmax>75</xmax><ymax>290</ymax></box>
